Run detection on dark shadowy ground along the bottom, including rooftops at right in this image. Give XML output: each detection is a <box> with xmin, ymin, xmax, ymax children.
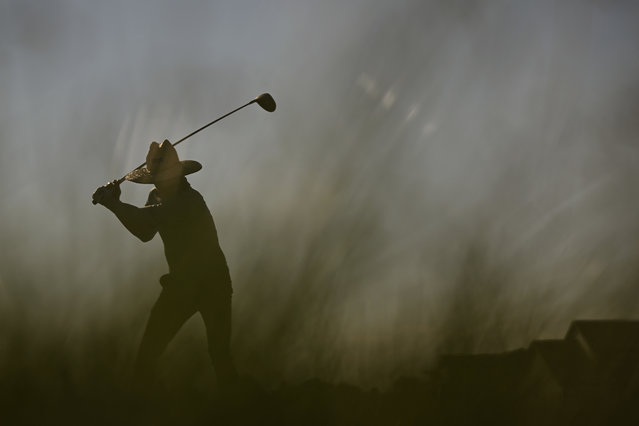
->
<box><xmin>0</xmin><ymin>321</ymin><xmax>639</xmax><ymax>425</ymax></box>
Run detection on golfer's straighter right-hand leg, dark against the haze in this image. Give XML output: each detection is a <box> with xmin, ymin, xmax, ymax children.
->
<box><xmin>198</xmin><ymin>292</ymin><xmax>237</xmax><ymax>389</ymax></box>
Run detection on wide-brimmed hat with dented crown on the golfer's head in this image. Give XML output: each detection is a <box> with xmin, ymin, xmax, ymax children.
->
<box><xmin>126</xmin><ymin>140</ymin><xmax>202</xmax><ymax>183</ymax></box>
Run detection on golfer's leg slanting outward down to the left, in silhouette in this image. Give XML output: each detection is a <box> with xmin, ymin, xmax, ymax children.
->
<box><xmin>135</xmin><ymin>289</ymin><xmax>196</xmax><ymax>384</ymax></box>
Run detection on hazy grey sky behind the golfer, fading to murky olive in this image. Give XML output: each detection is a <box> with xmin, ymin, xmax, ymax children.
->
<box><xmin>0</xmin><ymin>0</ymin><xmax>639</xmax><ymax>383</ymax></box>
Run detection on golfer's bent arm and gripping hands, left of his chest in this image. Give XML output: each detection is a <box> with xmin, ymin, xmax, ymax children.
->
<box><xmin>93</xmin><ymin>181</ymin><xmax>157</xmax><ymax>242</ymax></box>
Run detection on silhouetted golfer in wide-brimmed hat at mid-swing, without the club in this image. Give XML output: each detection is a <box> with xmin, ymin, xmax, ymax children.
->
<box><xmin>93</xmin><ymin>140</ymin><xmax>237</xmax><ymax>389</ymax></box>
